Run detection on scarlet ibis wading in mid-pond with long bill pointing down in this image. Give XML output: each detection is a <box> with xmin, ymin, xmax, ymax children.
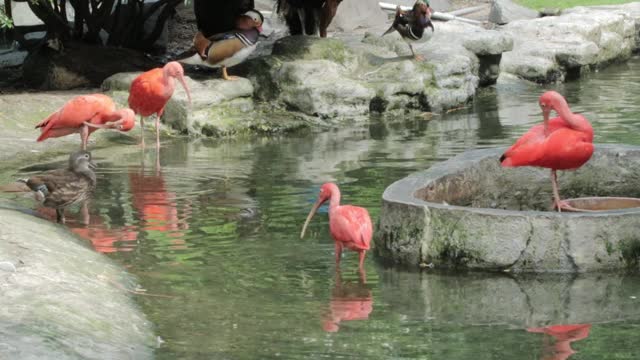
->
<box><xmin>300</xmin><ymin>183</ymin><xmax>373</xmax><ymax>270</ymax></box>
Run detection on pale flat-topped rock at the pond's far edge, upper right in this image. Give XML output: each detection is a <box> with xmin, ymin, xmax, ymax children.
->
<box><xmin>501</xmin><ymin>8</ymin><xmax>640</xmax><ymax>83</ymax></box>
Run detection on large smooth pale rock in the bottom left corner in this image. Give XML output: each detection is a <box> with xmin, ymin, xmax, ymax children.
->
<box><xmin>0</xmin><ymin>209</ymin><xmax>155</xmax><ymax>359</ymax></box>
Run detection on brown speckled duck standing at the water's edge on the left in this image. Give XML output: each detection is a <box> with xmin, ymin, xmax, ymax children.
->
<box><xmin>19</xmin><ymin>151</ymin><xmax>96</xmax><ymax>224</ymax></box>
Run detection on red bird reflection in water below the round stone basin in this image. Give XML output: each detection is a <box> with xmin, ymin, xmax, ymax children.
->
<box><xmin>527</xmin><ymin>324</ymin><xmax>591</xmax><ymax>360</ymax></box>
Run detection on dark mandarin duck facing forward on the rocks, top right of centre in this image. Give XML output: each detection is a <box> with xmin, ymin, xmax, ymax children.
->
<box><xmin>382</xmin><ymin>0</ymin><xmax>435</xmax><ymax>60</ymax></box>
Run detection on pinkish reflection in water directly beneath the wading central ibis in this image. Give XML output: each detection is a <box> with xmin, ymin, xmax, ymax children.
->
<box><xmin>322</xmin><ymin>269</ymin><xmax>373</xmax><ymax>332</ymax></box>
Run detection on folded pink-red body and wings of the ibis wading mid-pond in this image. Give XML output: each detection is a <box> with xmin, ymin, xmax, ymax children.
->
<box><xmin>330</xmin><ymin>205</ymin><xmax>373</xmax><ymax>250</ymax></box>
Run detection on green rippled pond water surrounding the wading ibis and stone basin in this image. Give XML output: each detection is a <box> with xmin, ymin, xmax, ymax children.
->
<box><xmin>3</xmin><ymin>58</ymin><xmax>640</xmax><ymax>360</ymax></box>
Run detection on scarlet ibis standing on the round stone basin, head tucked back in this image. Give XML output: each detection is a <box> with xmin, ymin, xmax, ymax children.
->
<box><xmin>500</xmin><ymin>91</ymin><xmax>593</xmax><ymax>211</ymax></box>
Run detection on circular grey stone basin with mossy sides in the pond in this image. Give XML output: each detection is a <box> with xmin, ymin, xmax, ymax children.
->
<box><xmin>374</xmin><ymin>145</ymin><xmax>640</xmax><ymax>272</ymax></box>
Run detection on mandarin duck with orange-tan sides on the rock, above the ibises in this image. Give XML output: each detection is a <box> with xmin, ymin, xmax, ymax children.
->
<box><xmin>178</xmin><ymin>10</ymin><xmax>264</xmax><ymax>80</ymax></box>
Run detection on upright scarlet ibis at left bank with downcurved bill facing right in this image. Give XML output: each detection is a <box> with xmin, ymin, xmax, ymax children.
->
<box><xmin>129</xmin><ymin>61</ymin><xmax>191</xmax><ymax>147</ymax></box>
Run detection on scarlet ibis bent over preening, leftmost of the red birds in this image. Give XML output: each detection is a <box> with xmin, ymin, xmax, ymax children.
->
<box><xmin>36</xmin><ymin>94</ymin><xmax>135</xmax><ymax>150</ymax></box>
